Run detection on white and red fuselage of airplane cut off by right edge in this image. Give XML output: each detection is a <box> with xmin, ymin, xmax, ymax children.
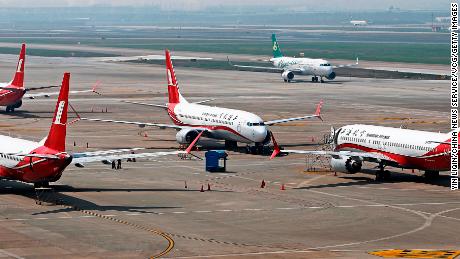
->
<box><xmin>334</xmin><ymin>124</ymin><xmax>450</xmax><ymax>171</ymax></box>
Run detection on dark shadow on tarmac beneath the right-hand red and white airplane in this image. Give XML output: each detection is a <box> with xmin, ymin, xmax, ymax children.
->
<box><xmin>294</xmin><ymin>170</ymin><xmax>450</xmax><ymax>190</ymax></box>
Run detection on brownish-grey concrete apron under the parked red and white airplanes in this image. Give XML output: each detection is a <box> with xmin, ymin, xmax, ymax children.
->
<box><xmin>0</xmin><ymin>53</ymin><xmax>460</xmax><ymax>258</ymax></box>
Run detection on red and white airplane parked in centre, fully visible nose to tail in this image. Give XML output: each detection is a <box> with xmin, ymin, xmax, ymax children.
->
<box><xmin>82</xmin><ymin>50</ymin><xmax>322</xmax><ymax>151</ymax></box>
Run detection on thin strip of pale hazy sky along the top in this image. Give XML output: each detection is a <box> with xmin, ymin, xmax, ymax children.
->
<box><xmin>0</xmin><ymin>0</ymin><xmax>451</xmax><ymax>11</ymax></box>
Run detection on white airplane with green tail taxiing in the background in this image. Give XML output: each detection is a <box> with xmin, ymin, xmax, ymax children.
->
<box><xmin>233</xmin><ymin>34</ymin><xmax>358</xmax><ymax>83</ymax></box>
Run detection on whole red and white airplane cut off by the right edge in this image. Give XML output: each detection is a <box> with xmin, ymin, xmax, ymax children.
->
<box><xmin>272</xmin><ymin>124</ymin><xmax>451</xmax><ymax>180</ymax></box>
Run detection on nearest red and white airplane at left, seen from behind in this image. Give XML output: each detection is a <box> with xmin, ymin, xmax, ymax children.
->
<box><xmin>0</xmin><ymin>73</ymin><xmax>181</xmax><ymax>187</ymax></box>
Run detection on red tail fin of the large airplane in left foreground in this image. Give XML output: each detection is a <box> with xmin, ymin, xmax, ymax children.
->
<box><xmin>45</xmin><ymin>73</ymin><xmax>70</xmax><ymax>152</ymax></box>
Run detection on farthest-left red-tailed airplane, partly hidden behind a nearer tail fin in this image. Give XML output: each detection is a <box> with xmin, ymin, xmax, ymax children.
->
<box><xmin>0</xmin><ymin>43</ymin><xmax>96</xmax><ymax>112</ymax></box>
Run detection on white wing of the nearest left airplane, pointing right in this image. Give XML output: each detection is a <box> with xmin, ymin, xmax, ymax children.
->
<box><xmin>72</xmin><ymin>148</ymin><xmax>186</xmax><ymax>167</ymax></box>
